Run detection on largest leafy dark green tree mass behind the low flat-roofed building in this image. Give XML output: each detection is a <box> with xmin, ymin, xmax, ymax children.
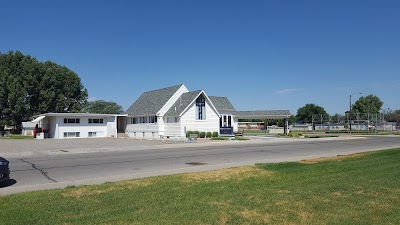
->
<box><xmin>0</xmin><ymin>51</ymin><xmax>87</xmax><ymax>129</ymax></box>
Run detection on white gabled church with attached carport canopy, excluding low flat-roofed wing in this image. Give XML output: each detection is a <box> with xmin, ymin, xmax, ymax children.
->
<box><xmin>125</xmin><ymin>84</ymin><xmax>290</xmax><ymax>138</ymax></box>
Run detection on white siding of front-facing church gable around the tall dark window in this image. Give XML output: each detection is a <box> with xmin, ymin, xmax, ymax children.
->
<box><xmin>180</xmin><ymin>99</ymin><xmax>219</xmax><ymax>137</ymax></box>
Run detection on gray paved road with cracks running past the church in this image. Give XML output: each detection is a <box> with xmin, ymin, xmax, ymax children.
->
<box><xmin>0</xmin><ymin>136</ymin><xmax>400</xmax><ymax>194</ymax></box>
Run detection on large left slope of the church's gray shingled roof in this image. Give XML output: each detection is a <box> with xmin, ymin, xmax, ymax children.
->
<box><xmin>125</xmin><ymin>84</ymin><xmax>183</xmax><ymax>116</ymax></box>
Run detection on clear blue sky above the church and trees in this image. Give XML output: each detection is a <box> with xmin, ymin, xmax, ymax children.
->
<box><xmin>0</xmin><ymin>0</ymin><xmax>400</xmax><ymax>114</ymax></box>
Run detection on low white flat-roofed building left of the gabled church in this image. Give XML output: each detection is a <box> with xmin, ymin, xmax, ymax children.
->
<box><xmin>32</xmin><ymin>113</ymin><xmax>126</xmax><ymax>139</ymax></box>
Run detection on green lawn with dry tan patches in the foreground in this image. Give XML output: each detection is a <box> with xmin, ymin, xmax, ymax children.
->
<box><xmin>0</xmin><ymin>149</ymin><xmax>400</xmax><ymax>225</ymax></box>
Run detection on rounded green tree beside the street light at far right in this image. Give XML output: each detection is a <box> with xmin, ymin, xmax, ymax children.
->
<box><xmin>351</xmin><ymin>95</ymin><xmax>383</xmax><ymax>114</ymax></box>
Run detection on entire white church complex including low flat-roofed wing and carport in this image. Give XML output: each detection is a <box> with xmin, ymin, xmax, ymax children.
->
<box><xmin>34</xmin><ymin>84</ymin><xmax>290</xmax><ymax>139</ymax></box>
